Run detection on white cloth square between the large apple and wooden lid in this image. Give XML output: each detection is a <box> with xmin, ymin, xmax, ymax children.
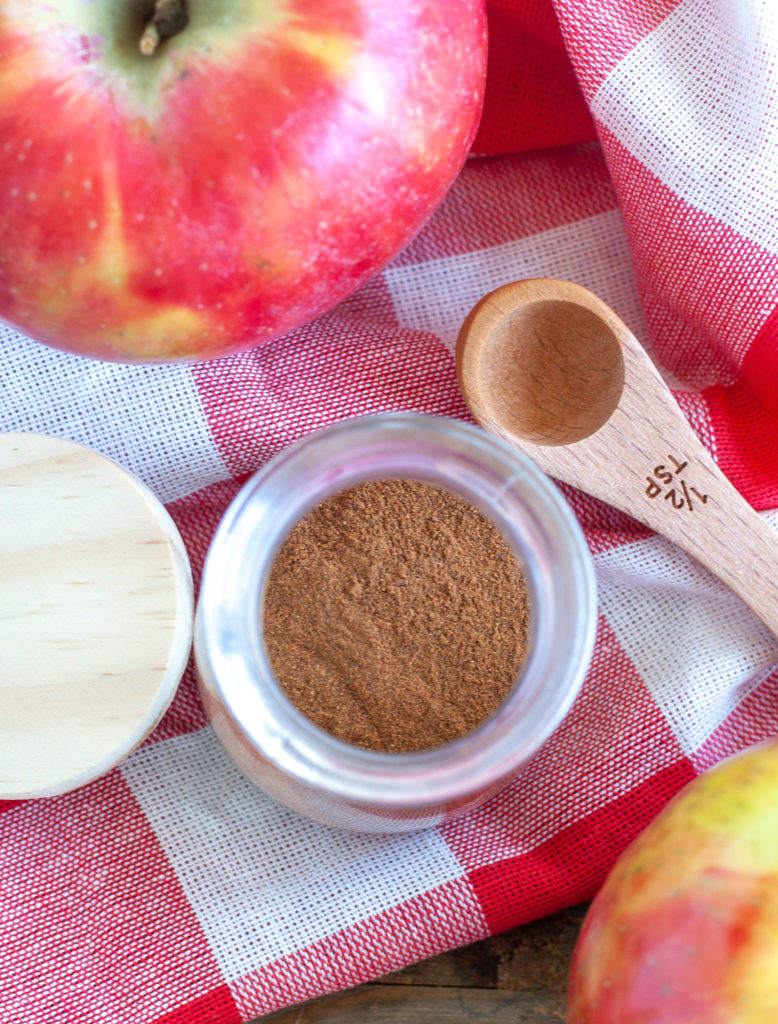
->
<box><xmin>0</xmin><ymin>326</ymin><xmax>229</xmax><ymax>502</ymax></box>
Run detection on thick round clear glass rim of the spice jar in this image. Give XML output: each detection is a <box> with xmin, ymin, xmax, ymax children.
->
<box><xmin>198</xmin><ymin>414</ymin><xmax>597</xmax><ymax>807</ymax></box>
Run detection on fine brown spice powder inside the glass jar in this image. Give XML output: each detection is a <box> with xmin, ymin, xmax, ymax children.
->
<box><xmin>264</xmin><ymin>480</ymin><xmax>529</xmax><ymax>753</ymax></box>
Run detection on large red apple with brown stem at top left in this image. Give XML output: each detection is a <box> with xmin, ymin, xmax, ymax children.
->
<box><xmin>0</xmin><ymin>0</ymin><xmax>486</xmax><ymax>361</ymax></box>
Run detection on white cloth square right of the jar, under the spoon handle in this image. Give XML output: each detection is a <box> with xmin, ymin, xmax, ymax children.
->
<box><xmin>595</xmin><ymin>512</ymin><xmax>778</xmax><ymax>754</ymax></box>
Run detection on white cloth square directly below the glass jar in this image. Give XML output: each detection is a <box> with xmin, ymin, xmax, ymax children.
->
<box><xmin>122</xmin><ymin>727</ymin><xmax>463</xmax><ymax>981</ymax></box>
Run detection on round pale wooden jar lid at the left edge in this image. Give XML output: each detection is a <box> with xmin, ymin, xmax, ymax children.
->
<box><xmin>0</xmin><ymin>434</ymin><xmax>192</xmax><ymax>800</ymax></box>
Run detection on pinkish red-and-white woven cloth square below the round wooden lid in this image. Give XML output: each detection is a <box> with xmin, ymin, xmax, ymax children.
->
<box><xmin>0</xmin><ymin>771</ymin><xmax>222</xmax><ymax>1024</ymax></box>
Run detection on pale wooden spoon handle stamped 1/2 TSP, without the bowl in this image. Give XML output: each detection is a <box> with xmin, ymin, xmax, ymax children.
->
<box><xmin>522</xmin><ymin>348</ymin><xmax>778</xmax><ymax>636</ymax></box>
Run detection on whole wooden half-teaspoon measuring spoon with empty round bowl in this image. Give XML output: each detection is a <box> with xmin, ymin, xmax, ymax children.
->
<box><xmin>457</xmin><ymin>278</ymin><xmax>778</xmax><ymax>635</ymax></box>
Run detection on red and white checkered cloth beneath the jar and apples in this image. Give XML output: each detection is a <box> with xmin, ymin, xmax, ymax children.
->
<box><xmin>0</xmin><ymin>0</ymin><xmax>778</xmax><ymax>1024</ymax></box>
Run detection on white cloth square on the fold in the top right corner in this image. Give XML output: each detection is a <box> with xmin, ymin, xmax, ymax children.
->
<box><xmin>592</xmin><ymin>0</ymin><xmax>778</xmax><ymax>253</ymax></box>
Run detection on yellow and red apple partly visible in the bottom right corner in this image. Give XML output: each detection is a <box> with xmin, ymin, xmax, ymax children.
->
<box><xmin>567</xmin><ymin>743</ymin><xmax>778</xmax><ymax>1024</ymax></box>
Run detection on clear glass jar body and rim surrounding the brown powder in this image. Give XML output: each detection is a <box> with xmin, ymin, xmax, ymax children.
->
<box><xmin>195</xmin><ymin>414</ymin><xmax>597</xmax><ymax>831</ymax></box>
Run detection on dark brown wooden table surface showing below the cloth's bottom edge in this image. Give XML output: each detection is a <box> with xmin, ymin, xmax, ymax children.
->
<box><xmin>251</xmin><ymin>904</ymin><xmax>587</xmax><ymax>1024</ymax></box>
